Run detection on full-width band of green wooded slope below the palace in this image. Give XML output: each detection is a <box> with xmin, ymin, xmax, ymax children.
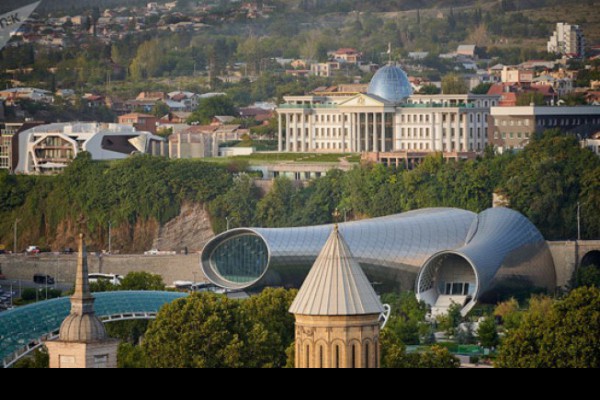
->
<box><xmin>0</xmin><ymin>132</ymin><xmax>600</xmax><ymax>252</ymax></box>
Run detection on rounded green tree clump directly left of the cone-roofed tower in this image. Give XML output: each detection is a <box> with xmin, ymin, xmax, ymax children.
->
<box><xmin>142</xmin><ymin>289</ymin><xmax>295</xmax><ymax>368</ymax></box>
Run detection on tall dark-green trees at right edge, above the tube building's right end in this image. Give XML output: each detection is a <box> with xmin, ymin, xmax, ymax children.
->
<box><xmin>500</xmin><ymin>131</ymin><xmax>600</xmax><ymax>240</ymax></box>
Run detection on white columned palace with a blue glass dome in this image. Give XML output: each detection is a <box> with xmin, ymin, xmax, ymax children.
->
<box><xmin>278</xmin><ymin>66</ymin><xmax>500</xmax><ymax>153</ymax></box>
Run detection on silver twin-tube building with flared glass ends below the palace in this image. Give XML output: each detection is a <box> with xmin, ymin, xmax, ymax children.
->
<box><xmin>202</xmin><ymin>208</ymin><xmax>556</xmax><ymax>314</ymax></box>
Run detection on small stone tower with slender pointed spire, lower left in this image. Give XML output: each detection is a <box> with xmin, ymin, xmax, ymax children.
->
<box><xmin>46</xmin><ymin>235</ymin><xmax>119</xmax><ymax>369</ymax></box>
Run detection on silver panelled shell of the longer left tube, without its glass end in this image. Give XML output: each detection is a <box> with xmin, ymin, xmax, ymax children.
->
<box><xmin>202</xmin><ymin>208</ymin><xmax>476</xmax><ymax>289</ymax></box>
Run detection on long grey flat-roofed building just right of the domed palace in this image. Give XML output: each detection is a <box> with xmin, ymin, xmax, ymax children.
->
<box><xmin>488</xmin><ymin>106</ymin><xmax>600</xmax><ymax>152</ymax></box>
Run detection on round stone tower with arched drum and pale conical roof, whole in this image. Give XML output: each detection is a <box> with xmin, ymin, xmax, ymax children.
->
<box><xmin>290</xmin><ymin>226</ymin><xmax>384</xmax><ymax>368</ymax></box>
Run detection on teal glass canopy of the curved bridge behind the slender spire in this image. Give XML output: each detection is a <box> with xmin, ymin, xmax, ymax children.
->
<box><xmin>0</xmin><ymin>292</ymin><xmax>187</xmax><ymax>361</ymax></box>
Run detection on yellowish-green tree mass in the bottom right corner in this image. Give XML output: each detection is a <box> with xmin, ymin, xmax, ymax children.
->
<box><xmin>497</xmin><ymin>288</ymin><xmax>600</xmax><ymax>368</ymax></box>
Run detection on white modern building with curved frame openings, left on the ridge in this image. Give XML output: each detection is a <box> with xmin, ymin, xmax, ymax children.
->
<box><xmin>13</xmin><ymin>123</ymin><xmax>166</xmax><ymax>174</ymax></box>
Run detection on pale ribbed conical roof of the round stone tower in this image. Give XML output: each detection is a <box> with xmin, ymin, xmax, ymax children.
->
<box><xmin>290</xmin><ymin>227</ymin><xmax>384</xmax><ymax>316</ymax></box>
